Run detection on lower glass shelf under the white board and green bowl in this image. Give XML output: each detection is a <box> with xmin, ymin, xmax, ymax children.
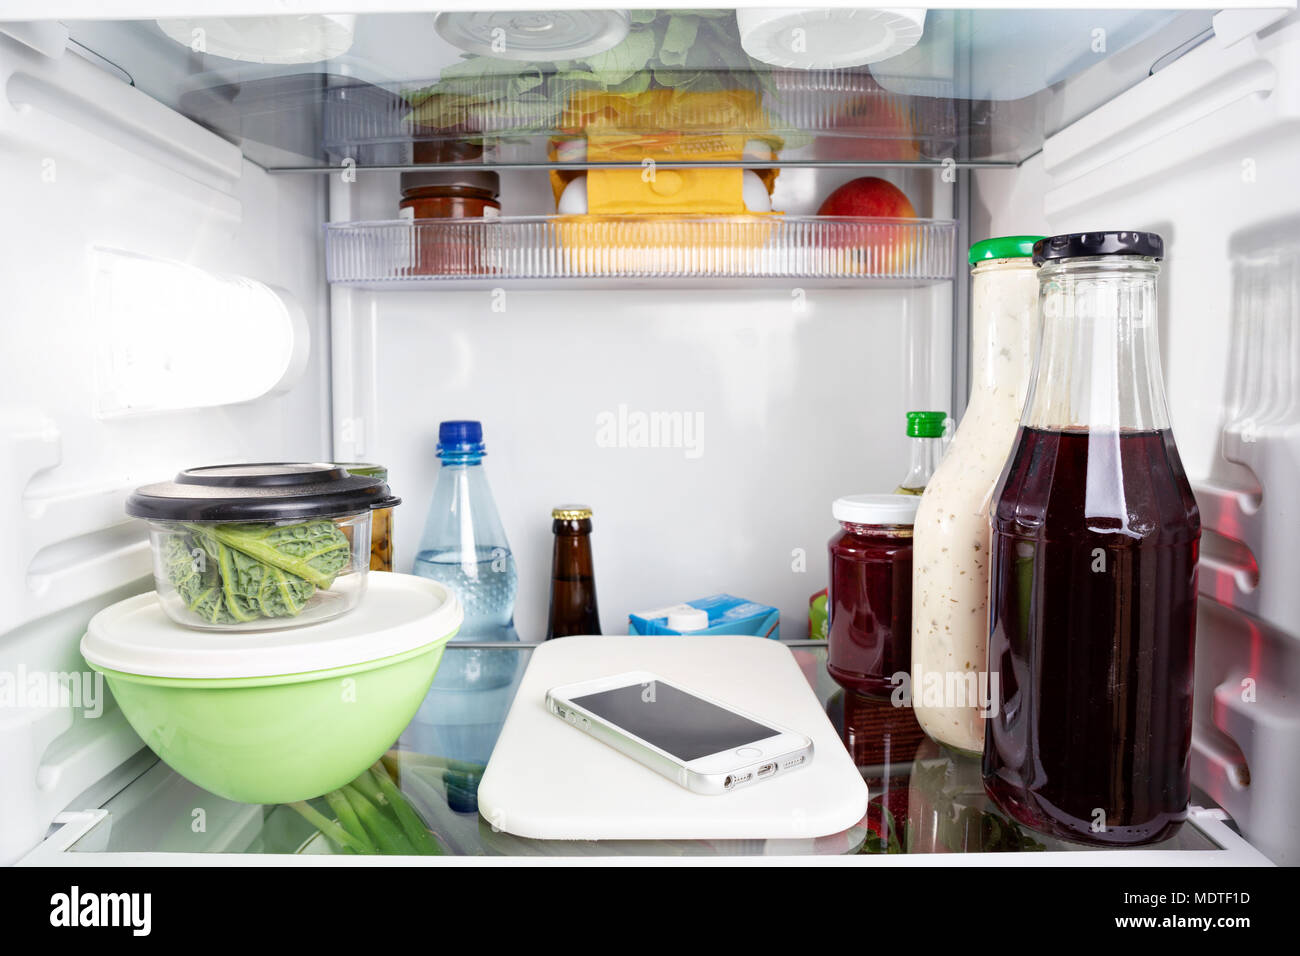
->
<box><xmin>70</xmin><ymin>641</ymin><xmax>1222</xmax><ymax>856</ymax></box>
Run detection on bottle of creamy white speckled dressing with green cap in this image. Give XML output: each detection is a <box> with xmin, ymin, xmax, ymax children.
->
<box><xmin>911</xmin><ymin>235</ymin><xmax>1041</xmax><ymax>753</ymax></box>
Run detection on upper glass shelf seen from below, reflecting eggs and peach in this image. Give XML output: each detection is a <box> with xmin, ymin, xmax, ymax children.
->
<box><xmin>61</xmin><ymin>9</ymin><xmax>1182</xmax><ymax>172</ymax></box>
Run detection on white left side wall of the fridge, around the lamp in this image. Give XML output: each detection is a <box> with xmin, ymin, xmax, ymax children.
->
<box><xmin>0</xmin><ymin>36</ymin><xmax>329</xmax><ymax>862</ymax></box>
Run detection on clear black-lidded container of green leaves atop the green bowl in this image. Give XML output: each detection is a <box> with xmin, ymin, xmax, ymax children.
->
<box><xmin>126</xmin><ymin>463</ymin><xmax>400</xmax><ymax>631</ymax></box>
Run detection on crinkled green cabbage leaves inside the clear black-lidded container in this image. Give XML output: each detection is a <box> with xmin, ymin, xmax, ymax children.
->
<box><xmin>163</xmin><ymin>519</ymin><xmax>352</xmax><ymax>624</ymax></box>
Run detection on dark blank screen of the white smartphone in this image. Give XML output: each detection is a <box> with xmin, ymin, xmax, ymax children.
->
<box><xmin>573</xmin><ymin>680</ymin><xmax>780</xmax><ymax>762</ymax></box>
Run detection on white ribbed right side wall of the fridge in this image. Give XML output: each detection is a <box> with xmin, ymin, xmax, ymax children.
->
<box><xmin>971</xmin><ymin>14</ymin><xmax>1300</xmax><ymax>864</ymax></box>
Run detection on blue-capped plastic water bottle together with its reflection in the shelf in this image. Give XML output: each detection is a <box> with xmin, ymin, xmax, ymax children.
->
<box><xmin>404</xmin><ymin>421</ymin><xmax>521</xmax><ymax>809</ymax></box>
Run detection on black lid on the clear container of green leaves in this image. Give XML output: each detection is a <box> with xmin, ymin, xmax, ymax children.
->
<box><xmin>126</xmin><ymin>462</ymin><xmax>402</xmax><ymax>522</ymax></box>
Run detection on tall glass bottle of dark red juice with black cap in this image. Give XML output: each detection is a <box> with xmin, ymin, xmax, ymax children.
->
<box><xmin>984</xmin><ymin>233</ymin><xmax>1200</xmax><ymax>845</ymax></box>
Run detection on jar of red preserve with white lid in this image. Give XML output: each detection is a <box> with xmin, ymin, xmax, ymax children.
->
<box><xmin>826</xmin><ymin>494</ymin><xmax>920</xmax><ymax>697</ymax></box>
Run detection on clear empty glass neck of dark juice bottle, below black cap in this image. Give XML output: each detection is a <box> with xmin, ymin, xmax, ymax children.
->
<box><xmin>1022</xmin><ymin>256</ymin><xmax>1169</xmax><ymax>431</ymax></box>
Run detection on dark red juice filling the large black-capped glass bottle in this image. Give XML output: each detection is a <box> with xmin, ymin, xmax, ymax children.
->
<box><xmin>985</xmin><ymin>428</ymin><xmax>1199</xmax><ymax>844</ymax></box>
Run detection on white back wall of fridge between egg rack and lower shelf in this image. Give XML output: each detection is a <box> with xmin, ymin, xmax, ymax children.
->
<box><xmin>373</xmin><ymin>289</ymin><xmax>945</xmax><ymax>640</ymax></box>
